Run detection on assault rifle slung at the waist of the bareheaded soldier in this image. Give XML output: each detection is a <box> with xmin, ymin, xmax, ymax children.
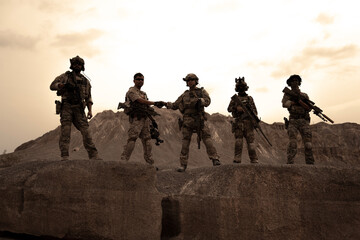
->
<box><xmin>117</xmin><ymin>102</ymin><xmax>164</xmax><ymax>146</ymax></box>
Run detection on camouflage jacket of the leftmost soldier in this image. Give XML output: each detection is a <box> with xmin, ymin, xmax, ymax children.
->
<box><xmin>50</xmin><ymin>71</ymin><xmax>93</xmax><ymax>105</ymax></box>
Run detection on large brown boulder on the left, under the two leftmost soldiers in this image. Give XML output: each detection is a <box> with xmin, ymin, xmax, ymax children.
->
<box><xmin>0</xmin><ymin>160</ymin><xmax>162</xmax><ymax>240</ymax></box>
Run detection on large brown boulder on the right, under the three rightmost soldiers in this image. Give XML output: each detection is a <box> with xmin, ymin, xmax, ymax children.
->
<box><xmin>158</xmin><ymin>164</ymin><xmax>360</xmax><ymax>240</ymax></box>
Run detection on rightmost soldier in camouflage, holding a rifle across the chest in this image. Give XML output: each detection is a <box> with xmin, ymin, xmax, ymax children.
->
<box><xmin>282</xmin><ymin>75</ymin><xmax>314</xmax><ymax>164</ymax></box>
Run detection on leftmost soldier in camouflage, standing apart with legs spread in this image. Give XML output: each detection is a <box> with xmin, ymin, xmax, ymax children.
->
<box><xmin>50</xmin><ymin>56</ymin><xmax>101</xmax><ymax>161</ymax></box>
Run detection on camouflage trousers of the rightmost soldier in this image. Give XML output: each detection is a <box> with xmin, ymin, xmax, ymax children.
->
<box><xmin>287</xmin><ymin>118</ymin><xmax>314</xmax><ymax>164</ymax></box>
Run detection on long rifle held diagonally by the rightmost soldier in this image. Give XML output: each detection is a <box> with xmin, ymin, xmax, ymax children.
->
<box><xmin>283</xmin><ymin>87</ymin><xmax>334</xmax><ymax>123</ymax></box>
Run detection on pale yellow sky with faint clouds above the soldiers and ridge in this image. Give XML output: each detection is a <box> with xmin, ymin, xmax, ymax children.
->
<box><xmin>0</xmin><ymin>0</ymin><xmax>360</xmax><ymax>153</ymax></box>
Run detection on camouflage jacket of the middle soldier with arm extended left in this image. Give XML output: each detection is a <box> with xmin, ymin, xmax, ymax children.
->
<box><xmin>166</xmin><ymin>88</ymin><xmax>211</xmax><ymax>115</ymax></box>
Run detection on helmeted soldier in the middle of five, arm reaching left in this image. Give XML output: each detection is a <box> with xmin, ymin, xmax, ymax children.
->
<box><xmin>166</xmin><ymin>73</ymin><xmax>220</xmax><ymax>172</ymax></box>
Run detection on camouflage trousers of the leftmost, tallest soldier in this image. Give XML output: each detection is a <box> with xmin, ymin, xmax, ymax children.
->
<box><xmin>59</xmin><ymin>103</ymin><xmax>98</xmax><ymax>158</ymax></box>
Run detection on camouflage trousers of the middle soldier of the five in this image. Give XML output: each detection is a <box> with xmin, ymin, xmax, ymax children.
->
<box><xmin>180</xmin><ymin>116</ymin><xmax>219</xmax><ymax>166</ymax></box>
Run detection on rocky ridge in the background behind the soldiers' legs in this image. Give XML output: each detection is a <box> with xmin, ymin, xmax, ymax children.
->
<box><xmin>0</xmin><ymin>109</ymin><xmax>360</xmax><ymax>168</ymax></box>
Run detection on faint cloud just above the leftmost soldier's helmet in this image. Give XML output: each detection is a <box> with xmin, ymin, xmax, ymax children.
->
<box><xmin>52</xmin><ymin>29</ymin><xmax>103</xmax><ymax>57</ymax></box>
